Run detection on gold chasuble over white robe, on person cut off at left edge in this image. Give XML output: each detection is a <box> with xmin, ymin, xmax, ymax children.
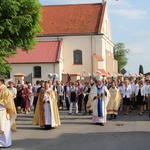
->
<box><xmin>0</xmin><ymin>84</ymin><xmax>17</xmax><ymax>134</ymax></box>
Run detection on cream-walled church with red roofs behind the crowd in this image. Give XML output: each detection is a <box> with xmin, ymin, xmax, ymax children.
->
<box><xmin>8</xmin><ymin>2</ymin><xmax>118</xmax><ymax>83</ymax></box>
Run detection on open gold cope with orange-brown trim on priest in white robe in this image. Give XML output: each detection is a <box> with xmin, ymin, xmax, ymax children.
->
<box><xmin>33</xmin><ymin>90</ymin><xmax>61</xmax><ymax>127</ymax></box>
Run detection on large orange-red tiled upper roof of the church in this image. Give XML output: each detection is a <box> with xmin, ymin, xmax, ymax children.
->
<box><xmin>41</xmin><ymin>3</ymin><xmax>106</xmax><ymax>35</ymax></box>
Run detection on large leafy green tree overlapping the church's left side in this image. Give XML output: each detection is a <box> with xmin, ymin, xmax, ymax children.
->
<box><xmin>0</xmin><ymin>0</ymin><xmax>42</xmax><ymax>76</ymax></box>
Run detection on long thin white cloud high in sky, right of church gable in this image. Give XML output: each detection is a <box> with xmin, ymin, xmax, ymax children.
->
<box><xmin>110</xmin><ymin>9</ymin><xmax>147</xmax><ymax>20</ymax></box>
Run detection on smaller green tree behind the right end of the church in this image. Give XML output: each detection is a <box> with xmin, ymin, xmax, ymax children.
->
<box><xmin>114</xmin><ymin>43</ymin><xmax>130</xmax><ymax>73</ymax></box>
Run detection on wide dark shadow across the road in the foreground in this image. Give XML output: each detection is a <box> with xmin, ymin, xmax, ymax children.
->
<box><xmin>5</xmin><ymin>131</ymin><xmax>150</xmax><ymax>150</ymax></box>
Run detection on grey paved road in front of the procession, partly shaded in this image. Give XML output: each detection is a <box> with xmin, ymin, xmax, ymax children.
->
<box><xmin>1</xmin><ymin>110</ymin><xmax>150</xmax><ymax>150</ymax></box>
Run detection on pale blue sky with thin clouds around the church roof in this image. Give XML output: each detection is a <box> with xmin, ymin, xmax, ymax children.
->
<box><xmin>39</xmin><ymin>0</ymin><xmax>150</xmax><ymax>74</ymax></box>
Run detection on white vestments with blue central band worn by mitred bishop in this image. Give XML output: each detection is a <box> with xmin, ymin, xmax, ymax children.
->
<box><xmin>91</xmin><ymin>85</ymin><xmax>110</xmax><ymax>123</ymax></box>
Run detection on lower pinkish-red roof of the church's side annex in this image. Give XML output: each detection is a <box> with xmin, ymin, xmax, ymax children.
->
<box><xmin>7</xmin><ymin>41</ymin><xmax>62</xmax><ymax>64</ymax></box>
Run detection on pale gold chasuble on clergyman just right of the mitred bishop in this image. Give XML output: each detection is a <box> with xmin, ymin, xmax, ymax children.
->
<box><xmin>107</xmin><ymin>87</ymin><xmax>121</xmax><ymax>115</ymax></box>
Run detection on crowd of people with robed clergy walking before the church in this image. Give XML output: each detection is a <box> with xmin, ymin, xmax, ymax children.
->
<box><xmin>0</xmin><ymin>74</ymin><xmax>150</xmax><ymax>147</ymax></box>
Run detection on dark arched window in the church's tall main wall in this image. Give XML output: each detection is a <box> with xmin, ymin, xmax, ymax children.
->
<box><xmin>73</xmin><ymin>50</ymin><xmax>82</xmax><ymax>64</ymax></box>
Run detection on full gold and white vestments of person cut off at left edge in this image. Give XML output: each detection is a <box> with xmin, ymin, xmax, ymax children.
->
<box><xmin>0</xmin><ymin>84</ymin><xmax>17</xmax><ymax>147</ymax></box>
